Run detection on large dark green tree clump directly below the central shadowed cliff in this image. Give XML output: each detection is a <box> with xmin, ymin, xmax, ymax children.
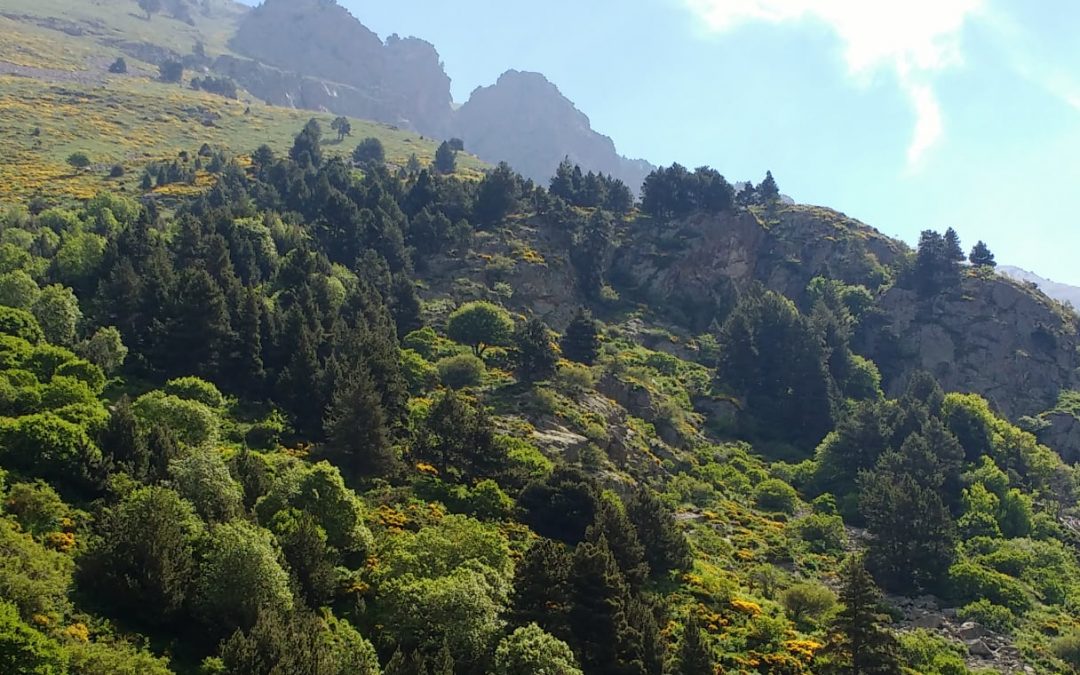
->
<box><xmin>718</xmin><ymin>291</ymin><xmax>831</xmax><ymax>447</ymax></box>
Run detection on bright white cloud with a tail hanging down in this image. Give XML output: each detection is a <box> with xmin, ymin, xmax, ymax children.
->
<box><xmin>684</xmin><ymin>0</ymin><xmax>985</xmax><ymax>165</ymax></box>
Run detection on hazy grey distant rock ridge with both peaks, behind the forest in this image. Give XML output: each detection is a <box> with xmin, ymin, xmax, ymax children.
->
<box><xmin>223</xmin><ymin>0</ymin><xmax>653</xmax><ymax>186</ymax></box>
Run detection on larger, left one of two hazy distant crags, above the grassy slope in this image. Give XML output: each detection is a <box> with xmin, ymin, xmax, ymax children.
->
<box><xmin>230</xmin><ymin>0</ymin><xmax>451</xmax><ymax>137</ymax></box>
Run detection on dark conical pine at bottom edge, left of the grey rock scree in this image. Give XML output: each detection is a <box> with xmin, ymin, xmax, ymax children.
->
<box><xmin>825</xmin><ymin>556</ymin><xmax>902</xmax><ymax>675</ymax></box>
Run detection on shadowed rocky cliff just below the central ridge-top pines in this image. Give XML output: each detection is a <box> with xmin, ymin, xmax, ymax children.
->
<box><xmin>611</xmin><ymin>205</ymin><xmax>905</xmax><ymax>330</ymax></box>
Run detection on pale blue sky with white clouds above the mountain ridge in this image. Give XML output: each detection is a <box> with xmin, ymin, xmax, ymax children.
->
<box><xmin>248</xmin><ymin>0</ymin><xmax>1080</xmax><ymax>284</ymax></box>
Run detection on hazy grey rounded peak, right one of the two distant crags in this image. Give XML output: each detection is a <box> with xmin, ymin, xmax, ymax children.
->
<box><xmin>454</xmin><ymin>70</ymin><xmax>653</xmax><ymax>191</ymax></box>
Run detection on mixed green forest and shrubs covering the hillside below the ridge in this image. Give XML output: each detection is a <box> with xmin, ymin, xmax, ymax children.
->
<box><xmin>0</xmin><ymin>110</ymin><xmax>1080</xmax><ymax>675</ymax></box>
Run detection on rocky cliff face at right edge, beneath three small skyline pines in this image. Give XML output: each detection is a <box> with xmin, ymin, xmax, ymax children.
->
<box><xmin>859</xmin><ymin>276</ymin><xmax>1080</xmax><ymax>419</ymax></box>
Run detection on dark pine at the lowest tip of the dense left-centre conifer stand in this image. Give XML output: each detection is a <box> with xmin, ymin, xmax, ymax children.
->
<box><xmin>324</xmin><ymin>367</ymin><xmax>397</xmax><ymax>476</ymax></box>
